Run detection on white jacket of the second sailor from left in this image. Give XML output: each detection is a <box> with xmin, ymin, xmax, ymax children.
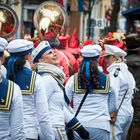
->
<box><xmin>13</xmin><ymin>65</ymin><xmax>54</xmax><ymax>140</ymax></box>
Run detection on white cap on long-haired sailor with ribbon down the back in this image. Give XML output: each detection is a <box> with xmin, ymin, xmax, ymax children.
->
<box><xmin>81</xmin><ymin>44</ymin><xmax>102</xmax><ymax>57</ymax></box>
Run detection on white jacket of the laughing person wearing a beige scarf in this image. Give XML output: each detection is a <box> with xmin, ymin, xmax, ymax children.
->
<box><xmin>42</xmin><ymin>75</ymin><xmax>65</xmax><ymax>127</ymax></box>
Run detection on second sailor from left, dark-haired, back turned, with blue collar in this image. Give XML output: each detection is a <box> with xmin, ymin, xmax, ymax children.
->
<box><xmin>7</xmin><ymin>39</ymin><xmax>54</xmax><ymax>140</ymax></box>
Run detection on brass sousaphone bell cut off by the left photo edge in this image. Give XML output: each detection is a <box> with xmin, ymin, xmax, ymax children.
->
<box><xmin>0</xmin><ymin>4</ymin><xmax>19</xmax><ymax>40</ymax></box>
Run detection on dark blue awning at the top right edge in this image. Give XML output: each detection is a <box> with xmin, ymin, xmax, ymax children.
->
<box><xmin>122</xmin><ymin>6</ymin><xmax>140</xmax><ymax>16</ymax></box>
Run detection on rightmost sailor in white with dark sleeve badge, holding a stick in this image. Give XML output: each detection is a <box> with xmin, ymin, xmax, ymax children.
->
<box><xmin>104</xmin><ymin>44</ymin><xmax>135</xmax><ymax>140</ymax></box>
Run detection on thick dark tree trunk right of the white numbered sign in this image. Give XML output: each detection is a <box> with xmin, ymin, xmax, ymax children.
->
<box><xmin>110</xmin><ymin>0</ymin><xmax>120</xmax><ymax>32</ymax></box>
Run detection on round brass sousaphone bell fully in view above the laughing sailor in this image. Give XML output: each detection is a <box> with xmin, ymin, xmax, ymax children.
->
<box><xmin>34</xmin><ymin>1</ymin><xmax>66</xmax><ymax>36</ymax></box>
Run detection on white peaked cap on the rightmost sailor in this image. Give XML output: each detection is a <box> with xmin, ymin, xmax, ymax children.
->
<box><xmin>103</xmin><ymin>44</ymin><xmax>127</xmax><ymax>57</ymax></box>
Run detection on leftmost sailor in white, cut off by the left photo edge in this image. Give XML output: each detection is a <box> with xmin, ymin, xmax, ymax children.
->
<box><xmin>0</xmin><ymin>38</ymin><xmax>25</xmax><ymax>140</ymax></box>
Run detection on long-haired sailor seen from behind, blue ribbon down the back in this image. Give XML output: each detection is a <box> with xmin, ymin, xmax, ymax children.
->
<box><xmin>65</xmin><ymin>44</ymin><xmax>116</xmax><ymax>140</ymax></box>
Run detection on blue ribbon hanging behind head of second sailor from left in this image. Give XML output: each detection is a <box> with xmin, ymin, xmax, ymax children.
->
<box><xmin>7</xmin><ymin>56</ymin><xmax>19</xmax><ymax>78</ymax></box>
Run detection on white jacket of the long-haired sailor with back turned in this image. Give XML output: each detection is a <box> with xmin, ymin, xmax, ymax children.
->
<box><xmin>65</xmin><ymin>74</ymin><xmax>116</xmax><ymax>131</ymax></box>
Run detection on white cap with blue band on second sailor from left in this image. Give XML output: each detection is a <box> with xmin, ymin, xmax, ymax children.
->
<box><xmin>6</xmin><ymin>39</ymin><xmax>33</xmax><ymax>57</ymax></box>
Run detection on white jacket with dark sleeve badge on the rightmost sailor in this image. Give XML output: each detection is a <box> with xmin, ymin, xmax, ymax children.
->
<box><xmin>107</xmin><ymin>62</ymin><xmax>135</xmax><ymax>116</ymax></box>
